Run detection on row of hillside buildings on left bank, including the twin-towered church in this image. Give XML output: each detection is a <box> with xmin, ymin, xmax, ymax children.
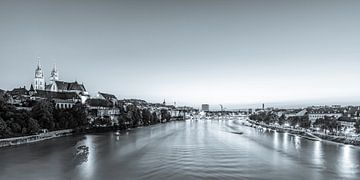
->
<box><xmin>0</xmin><ymin>61</ymin><xmax>197</xmax><ymax>124</ymax></box>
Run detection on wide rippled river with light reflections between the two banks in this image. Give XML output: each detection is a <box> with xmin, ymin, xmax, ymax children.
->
<box><xmin>0</xmin><ymin>120</ymin><xmax>360</xmax><ymax>180</ymax></box>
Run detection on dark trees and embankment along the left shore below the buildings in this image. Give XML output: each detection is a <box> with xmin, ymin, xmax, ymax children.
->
<box><xmin>0</xmin><ymin>99</ymin><xmax>171</xmax><ymax>147</ymax></box>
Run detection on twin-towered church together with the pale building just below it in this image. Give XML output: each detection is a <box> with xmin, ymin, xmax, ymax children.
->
<box><xmin>30</xmin><ymin>61</ymin><xmax>90</xmax><ymax>108</ymax></box>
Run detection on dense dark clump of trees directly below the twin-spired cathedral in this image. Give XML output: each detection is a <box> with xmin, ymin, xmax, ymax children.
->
<box><xmin>0</xmin><ymin>99</ymin><xmax>88</xmax><ymax>138</ymax></box>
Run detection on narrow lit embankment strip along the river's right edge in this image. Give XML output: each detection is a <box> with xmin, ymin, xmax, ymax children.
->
<box><xmin>247</xmin><ymin>119</ymin><xmax>360</xmax><ymax>146</ymax></box>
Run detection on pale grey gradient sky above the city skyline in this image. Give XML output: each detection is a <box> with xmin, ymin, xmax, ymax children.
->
<box><xmin>0</xmin><ymin>0</ymin><xmax>360</xmax><ymax>108</ymax></box>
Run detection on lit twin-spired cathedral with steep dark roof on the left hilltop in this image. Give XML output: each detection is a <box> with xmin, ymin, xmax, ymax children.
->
<box><xmin>30</xmin><ymin>61</ymin><xmax>89</xmax><ymax>103</ymax></box>
